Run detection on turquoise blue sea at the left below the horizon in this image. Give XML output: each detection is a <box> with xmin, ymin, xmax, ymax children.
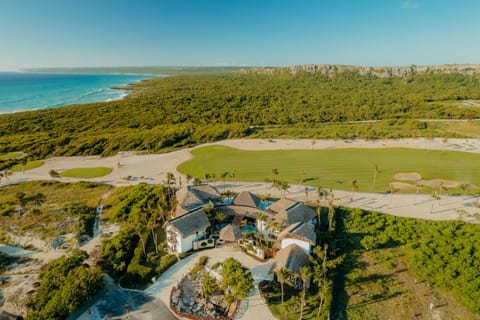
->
<box><xmin>0</xmin><ymin>72</ymin><xmax>159</xmax><ymax>113</ymax></box>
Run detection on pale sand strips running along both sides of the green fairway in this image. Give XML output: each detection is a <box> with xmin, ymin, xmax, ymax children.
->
<box><xmin>0</xmin><ymin>138</ymin><xmax>480</xmax><ymax>222</ymax></box>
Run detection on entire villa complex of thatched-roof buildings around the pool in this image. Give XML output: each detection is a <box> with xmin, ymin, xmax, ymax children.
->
<box><xmin>165</xmin><ymin>185</ymin><xmax>317</xmax><ymax>262</ymax></box>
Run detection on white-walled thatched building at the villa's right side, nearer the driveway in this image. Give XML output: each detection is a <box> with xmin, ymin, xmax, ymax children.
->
<box><xmin>276</xmin><ymin>222</ymin><xmax>317</xmax><ymax>255</ymax></box>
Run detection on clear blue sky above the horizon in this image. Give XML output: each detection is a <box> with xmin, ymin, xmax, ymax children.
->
<box><xmin>0</xmin><ymin>0</ymin><xmax>480</xmax><ymax>70</ymax></box>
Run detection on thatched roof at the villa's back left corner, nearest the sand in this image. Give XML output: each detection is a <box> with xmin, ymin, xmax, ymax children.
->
<box><xmin>175</xmin><ymin>184</ymin><xmax>221</xmax><ymax>209</ymax></box>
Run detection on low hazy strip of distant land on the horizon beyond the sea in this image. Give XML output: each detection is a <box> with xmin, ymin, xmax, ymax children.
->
<box><xmin>22</xmin><ymin>66</ymin><xmax>246</xmax><ymax>75</ymax></box>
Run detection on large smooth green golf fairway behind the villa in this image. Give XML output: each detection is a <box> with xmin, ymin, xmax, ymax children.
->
<box><xmin>177</xmin><ymin>146</ymin><xmax>480</xmax><ymax>193</ymax></box>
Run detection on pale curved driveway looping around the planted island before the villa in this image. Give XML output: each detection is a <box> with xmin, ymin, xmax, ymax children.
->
<box><xmin>77</xmin><ymin>246</ymin><xmax>275</xmax><ymax>320</ymax></box>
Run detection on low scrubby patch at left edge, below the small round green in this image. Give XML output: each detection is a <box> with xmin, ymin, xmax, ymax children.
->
<box><xmin>0</xmin><ymin>181</ymin><xmax>112</xmax><ymax>240</ymax></box>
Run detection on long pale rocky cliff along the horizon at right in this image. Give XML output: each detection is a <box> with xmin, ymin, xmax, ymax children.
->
<box><xmin>240</xmin><ymin>64</ymin><xmax>480</xmax><ymax>78</ymax></box>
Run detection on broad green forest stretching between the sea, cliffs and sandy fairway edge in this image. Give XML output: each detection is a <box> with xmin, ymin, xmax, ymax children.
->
<box><xmin>0</xmin><ymin>71</ymin><xmax>480</xmax><ymax>158</ymax></box>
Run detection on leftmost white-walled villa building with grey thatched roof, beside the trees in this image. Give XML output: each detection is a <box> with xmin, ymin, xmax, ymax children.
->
<box><xmin>165</xmin><ymin>208</ymin><xmax>210</xmax><ymax>253</ymax></box>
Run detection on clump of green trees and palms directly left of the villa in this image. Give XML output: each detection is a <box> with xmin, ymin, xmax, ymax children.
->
<box><xmin>102</xmin><ymin>184</ymin><xmax>177</xmax><ymax>288</ymax></box>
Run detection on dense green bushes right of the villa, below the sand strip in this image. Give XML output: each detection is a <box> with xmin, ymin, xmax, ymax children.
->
<box><xmin>331</xmin><ymin>209</ymin><xmax>480</xmax><ymax>319</ymax></box>
